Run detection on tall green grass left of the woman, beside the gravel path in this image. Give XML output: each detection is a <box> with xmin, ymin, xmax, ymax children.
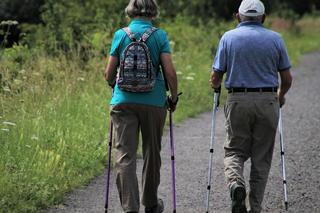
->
<box><xmin>0</xmin><ymin>47</ymin><xmax>110</xmax><ymax>212</ymax></box>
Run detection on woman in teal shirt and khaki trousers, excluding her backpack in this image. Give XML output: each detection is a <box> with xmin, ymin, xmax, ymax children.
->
<box><xmin>105</xmin><ymin>0</ymin><xmax>178</xmax><ymax>213</ymax></box>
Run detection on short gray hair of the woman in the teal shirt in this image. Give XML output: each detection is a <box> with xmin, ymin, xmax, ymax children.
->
<box><xmin>125</xmin><ymin>0</ymin><xmax>159</xmax><ymax>18</ymax></box>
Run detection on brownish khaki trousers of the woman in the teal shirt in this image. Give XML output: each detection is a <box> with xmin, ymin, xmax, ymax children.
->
<box><xmin>110</xmin><ymin>104</ymin><xmax>166</xmax><ymax>212</ymax></box>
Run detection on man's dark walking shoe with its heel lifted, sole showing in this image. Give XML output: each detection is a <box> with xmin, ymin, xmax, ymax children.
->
<box><xmin>230</xmin><ymin>182</ymin><xmax>247</xmax><ymax>213</ymax></box>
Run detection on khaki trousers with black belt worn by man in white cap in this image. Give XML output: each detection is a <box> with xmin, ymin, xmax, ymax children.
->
<box><xmin>224</xmin><ymin>92</ymin><xmax>279</xmax><ymax>213</ymax></box>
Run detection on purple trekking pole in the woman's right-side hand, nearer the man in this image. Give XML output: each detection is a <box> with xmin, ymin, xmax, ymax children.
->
<box><xmin>169</xmin><ymin>92</ymin><xmax>182</xmax><ymax>213</ymax></box>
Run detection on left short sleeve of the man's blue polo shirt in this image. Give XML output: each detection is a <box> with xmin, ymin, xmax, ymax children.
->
<box><xmin>212</xmin><ymin>36</ymin><xmax>227</xmax><ymax>73</ymax></box>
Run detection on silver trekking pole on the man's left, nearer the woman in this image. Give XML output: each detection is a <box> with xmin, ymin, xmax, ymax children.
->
<box><xmin>206</xmin><ymin>87</ymin><xmax>221</xmax><ymax>213</ymax></box>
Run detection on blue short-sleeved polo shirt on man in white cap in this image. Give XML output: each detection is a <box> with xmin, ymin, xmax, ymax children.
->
<box><xmin>212</xmin><ymin>22</ymin><xmax>291</xmax><ymax>88</ymax></box>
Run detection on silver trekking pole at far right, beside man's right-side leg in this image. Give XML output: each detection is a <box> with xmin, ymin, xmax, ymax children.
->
<box><xmin>279</xmin><ymin>108</ymin><xmax>288</xmax><ymax>211</ymax></box>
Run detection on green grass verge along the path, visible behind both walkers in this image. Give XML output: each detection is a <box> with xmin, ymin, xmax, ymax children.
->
<box><xmin>0</xmin><ymin>17</ymin><xmax>320</xmax><ymax>212</ymax></box>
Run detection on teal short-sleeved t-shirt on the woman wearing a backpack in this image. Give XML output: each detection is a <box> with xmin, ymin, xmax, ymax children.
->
<box><xmin>110</xmin><ymin>19</ymin><xmax>171</xmax><ymax>107</ymax></box>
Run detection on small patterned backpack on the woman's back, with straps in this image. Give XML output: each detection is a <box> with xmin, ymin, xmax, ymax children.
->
<box><xmin>117</xmin><ymin>27</ymin><xmax>157</xmax><ymax>92</ymax></box>
